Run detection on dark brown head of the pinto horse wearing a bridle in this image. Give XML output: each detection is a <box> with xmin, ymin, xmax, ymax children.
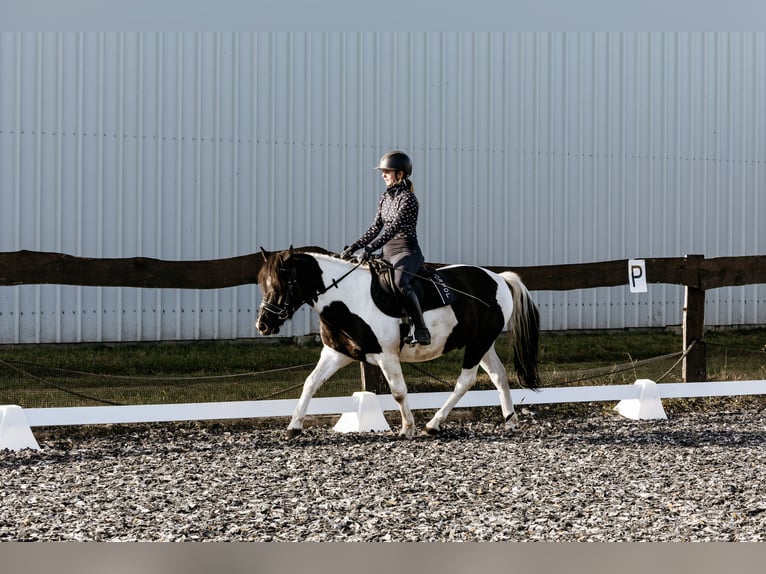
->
<box><xmin>255</xmin><ymin>246</ymin><xmax>324</xmax><ymax>335</ymax></box>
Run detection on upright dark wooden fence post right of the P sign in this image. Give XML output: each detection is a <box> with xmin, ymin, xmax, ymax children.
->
<box><xmin>681</xmin><ymin>255</ymin><xmax>707</xmax><ymax>382</ymax></box>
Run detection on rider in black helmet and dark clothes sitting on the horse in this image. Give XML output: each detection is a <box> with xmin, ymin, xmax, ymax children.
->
<box><xmin>341</xmin><ymin>151</ymin><xmax>431</xmax><ymax>345</ymax></box>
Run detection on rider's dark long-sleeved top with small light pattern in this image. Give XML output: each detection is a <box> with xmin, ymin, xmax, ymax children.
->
<box><xmin>351</xmin><ymin>181</ymin><xmax>419</xmax><ymax>255</ymax></box>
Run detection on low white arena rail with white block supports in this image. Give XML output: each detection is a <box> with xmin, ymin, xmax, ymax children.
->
<box><xmin>0</xmin><ymin>379</ymin><xmax>766</xmax><ymax>450</ymax></box>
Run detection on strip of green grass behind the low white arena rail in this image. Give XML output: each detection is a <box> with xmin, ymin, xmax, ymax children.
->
<box><xmin>0</xmin><ymin>329</ymin><xmax>766</xmax><ymax>414</ymax></box>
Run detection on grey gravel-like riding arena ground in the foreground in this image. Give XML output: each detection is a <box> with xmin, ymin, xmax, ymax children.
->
<box><xmin>0</xmin><ymin>408</ymin><xmax>766</xmax><ymax>542</ymax></box>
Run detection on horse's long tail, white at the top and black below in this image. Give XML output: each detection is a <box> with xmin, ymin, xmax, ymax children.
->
<box><xmin>500</xmin><ymin>271</ymin><xmax>540</xmax><ymax>389</ymax></box>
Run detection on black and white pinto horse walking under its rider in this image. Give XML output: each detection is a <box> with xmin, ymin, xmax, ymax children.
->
<box><xmin>255</xmin><ymin>246</ymin><xmax>540</xmax><ymax>439</ymax></box>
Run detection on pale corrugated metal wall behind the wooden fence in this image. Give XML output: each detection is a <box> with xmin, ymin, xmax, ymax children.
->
<box><xmin>0</xmin><ymin>33</ymin><xmax>766</xmax><ymax>343</ymax></box>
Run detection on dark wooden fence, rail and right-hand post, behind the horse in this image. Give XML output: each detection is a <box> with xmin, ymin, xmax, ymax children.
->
<box><xmin>0</xmin><ymin>251</ymin><xmax>766</xmax><ymax>381</ymax></box>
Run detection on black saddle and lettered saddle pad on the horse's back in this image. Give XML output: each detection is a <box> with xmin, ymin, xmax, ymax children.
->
<box><xmin>369</xmin><ymin>258</ymin><xmax>457</xmax><ymax>317</ymax></box>
